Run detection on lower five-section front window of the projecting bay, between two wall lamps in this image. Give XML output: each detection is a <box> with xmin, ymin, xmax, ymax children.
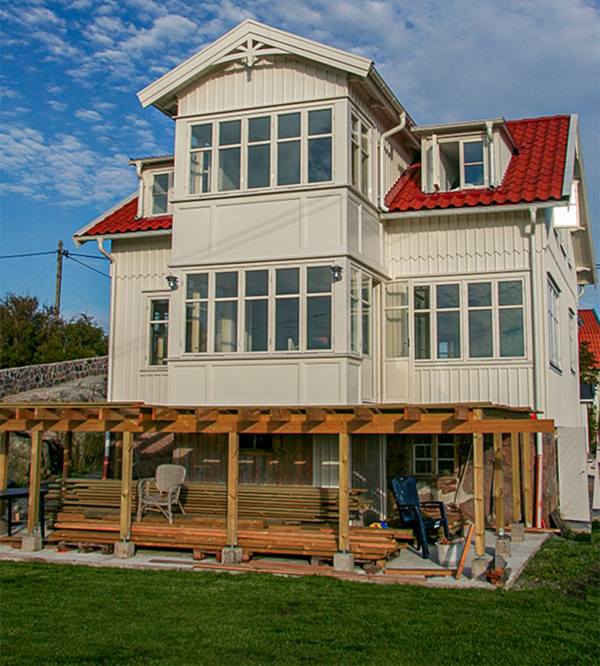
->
<box><xmin>185</xmin><ymin>266</ymin><xmax>333</xmax><ymax>354</ymax></box>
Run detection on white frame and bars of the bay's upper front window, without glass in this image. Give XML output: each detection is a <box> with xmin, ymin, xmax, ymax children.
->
<box><xmin>185</xmin><ymin>104</ymin><xmax>336</xmax><ymax>198</ymax></box>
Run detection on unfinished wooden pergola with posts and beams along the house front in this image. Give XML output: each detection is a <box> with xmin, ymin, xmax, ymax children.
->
<box><xmin>0</xmin><ymin>403</ymin><xmax>554</xmax><ymax>556</ymax></box>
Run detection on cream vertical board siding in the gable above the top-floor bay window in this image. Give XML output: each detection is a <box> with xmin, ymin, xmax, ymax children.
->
<box><xmin>179</xmin><ymin>56</ymin><xmax>347</xmax><ymax>116</ymax></box>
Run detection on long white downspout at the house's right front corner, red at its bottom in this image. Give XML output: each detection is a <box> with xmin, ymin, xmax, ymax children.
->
<box><xmin>528</xmin><ymin>208</ymin><xmax>544</xmax><ymax>527</ymax></box>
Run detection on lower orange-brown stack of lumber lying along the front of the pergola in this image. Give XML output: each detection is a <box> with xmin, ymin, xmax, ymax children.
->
<box><xmin>50</xmin><ymin>513</ymin><xmax>413</xmax><ymax>561</ymax></box>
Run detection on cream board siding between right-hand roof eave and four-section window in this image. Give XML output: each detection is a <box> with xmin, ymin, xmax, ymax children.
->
<box><xmin>386</xmin><ymin>212</ymin><xmax>529</xmax><ymax>278</ymax></box>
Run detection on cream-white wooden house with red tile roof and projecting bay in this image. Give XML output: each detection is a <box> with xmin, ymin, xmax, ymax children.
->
<box><xmin>74</xmin><ymin>20</ymin><xmax>597</xmax><ymax>523</ymax></box>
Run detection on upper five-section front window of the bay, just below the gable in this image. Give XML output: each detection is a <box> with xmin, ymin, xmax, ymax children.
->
<box><xmin>188</xmin><ymin>109</ymin><xmax>332</xmax><ymax>194</ymax></box>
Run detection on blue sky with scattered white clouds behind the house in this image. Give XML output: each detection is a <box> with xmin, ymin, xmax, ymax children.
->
<box><xmin>0</xmin><ymin>0</ymin><xmax>600</xmax><ymax>326</ymax></box>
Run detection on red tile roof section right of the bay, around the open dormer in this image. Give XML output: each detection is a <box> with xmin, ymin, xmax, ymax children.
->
<box><xmin>385</xmin><ymin>116</ymin><xmax>571</xmax><ymax>211</ymax></box>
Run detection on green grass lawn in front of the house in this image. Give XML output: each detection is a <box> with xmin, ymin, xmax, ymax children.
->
<box><xmin>0</xmin><ymin>532</ymin><xmax>600</xmax><ymax>666</ymax></box>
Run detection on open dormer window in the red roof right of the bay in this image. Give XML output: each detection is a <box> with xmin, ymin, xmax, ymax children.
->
<box><xmin>438</xmin><ymin>139</ymin><xmax>486</xmax><ymax>192</ymax></box>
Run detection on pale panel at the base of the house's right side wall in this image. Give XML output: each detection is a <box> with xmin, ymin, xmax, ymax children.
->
<box><xmin>556</xmin><ymin>427</ymin><xmax>590</xmax><ymax>522</ymax></box>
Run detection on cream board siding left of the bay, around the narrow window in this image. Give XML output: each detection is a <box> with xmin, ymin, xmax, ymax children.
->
<box><xmin>110</xmin><ymin>235</ymin><xmax>171</xmax><ymax>404</ymax></box>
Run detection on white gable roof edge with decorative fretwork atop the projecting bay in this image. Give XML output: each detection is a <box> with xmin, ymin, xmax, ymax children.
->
<box><xmin>138</xmin><ymin>19</ymin><xmax>376</xmax><ymax>115</ymax></box>
